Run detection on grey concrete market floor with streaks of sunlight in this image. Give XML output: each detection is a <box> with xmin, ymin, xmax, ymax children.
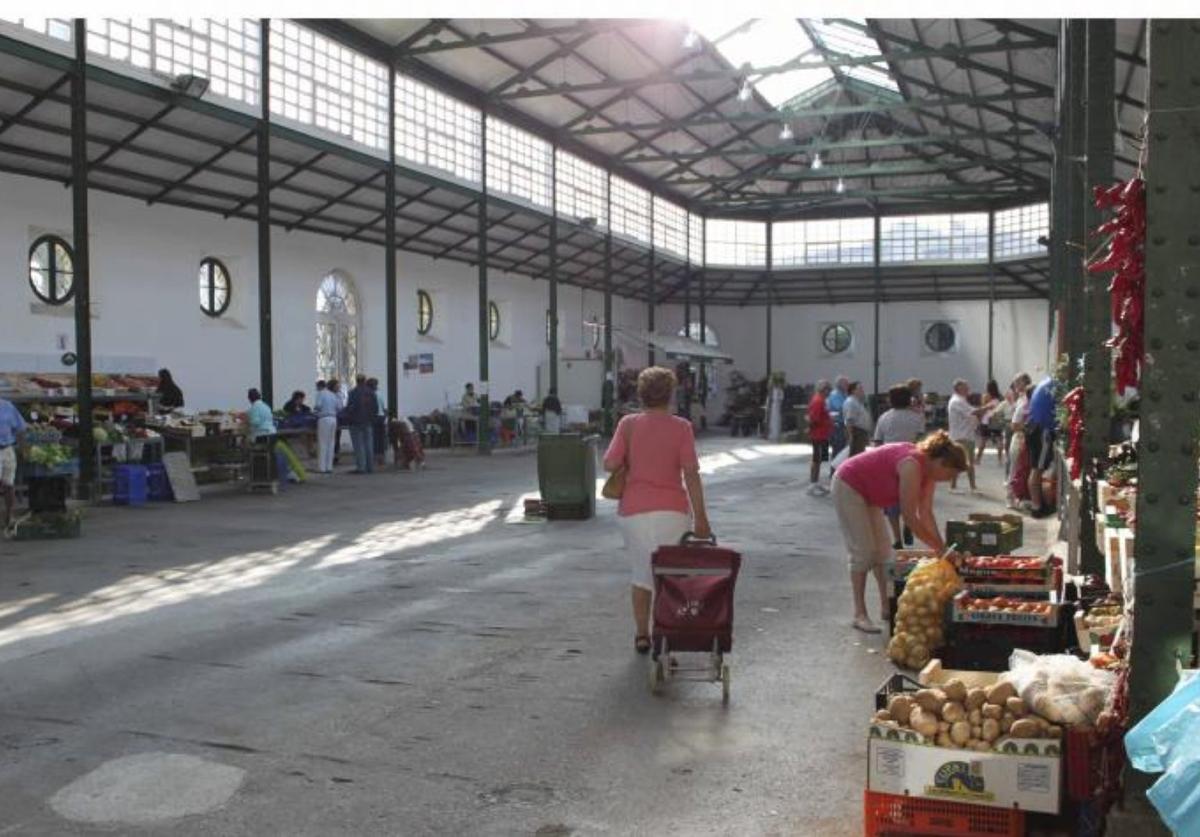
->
<box><xmin>0</xmin><ymin>438</ymin><xmax>1046</xmax><ymax>836</ymax></box>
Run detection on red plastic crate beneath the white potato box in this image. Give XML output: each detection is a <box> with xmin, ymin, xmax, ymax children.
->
<box><xmin>863</xmin><ymin>790</ymin><xmax>1025</xmax><ymax>837</ymax></box>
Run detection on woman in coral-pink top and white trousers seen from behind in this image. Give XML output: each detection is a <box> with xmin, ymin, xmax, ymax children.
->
<box><xmin>604</xmin><ymin>366</ymin><xmax>712</xmax><ymax>654</ymax></box>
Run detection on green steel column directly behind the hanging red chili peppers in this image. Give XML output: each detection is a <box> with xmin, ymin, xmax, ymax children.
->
<box><xmin>1079</xmin><ymin>19</ymin><xmax>1116</xmax><ymax>574</ymax></box>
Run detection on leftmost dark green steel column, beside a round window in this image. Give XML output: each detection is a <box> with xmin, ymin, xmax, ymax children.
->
<box><xmin>71</xmin><ymin>18</ymin><xmax>97</xmax><ymax>500</ymax></box>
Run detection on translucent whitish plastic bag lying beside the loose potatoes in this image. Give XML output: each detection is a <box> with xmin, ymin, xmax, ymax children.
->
<box><xmin>1001</xmin><ymin>650</ymin><xmax>1116</xmax><ymax>727</ymax></box>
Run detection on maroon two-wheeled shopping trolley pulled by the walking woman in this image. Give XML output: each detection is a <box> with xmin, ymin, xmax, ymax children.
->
<box><xmin>650</xmin><ymin>532</ymin><xmax>742</xmax><ymax>703</ymax></box>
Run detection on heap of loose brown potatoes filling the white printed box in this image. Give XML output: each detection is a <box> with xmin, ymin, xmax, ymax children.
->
<box><xmin>874</xmin><ymin>680</ymin><xmax>1062</xmax><ymax>752</ymax></box>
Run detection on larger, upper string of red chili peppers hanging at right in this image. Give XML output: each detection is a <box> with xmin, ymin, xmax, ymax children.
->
<box><xmin>1087</xmin><ymin>177</ymin><xmax>1146</xmax><ymax>395</ymax></box>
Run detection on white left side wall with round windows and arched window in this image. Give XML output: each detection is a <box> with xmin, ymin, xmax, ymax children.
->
<box><xmin>0</xmin><ymin>175</ymin><xmax>644</xmax><ymax>414</ymax></box>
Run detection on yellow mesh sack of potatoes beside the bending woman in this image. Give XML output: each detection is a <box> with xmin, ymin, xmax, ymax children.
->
<box><xmin>888</xmin><ymin>558</ymin><xmax>962</xmax><ymax>670</ymax></box>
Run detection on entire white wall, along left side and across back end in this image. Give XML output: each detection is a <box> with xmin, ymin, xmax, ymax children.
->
<box><xmin>0</xmin><ymin>169</ymin><xmax>1049</xmax><ymax>417</ymax></box>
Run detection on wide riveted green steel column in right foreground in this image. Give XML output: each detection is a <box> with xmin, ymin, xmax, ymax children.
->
<box><xmin>1129</xmin><ymin>11</ymin><xmax>1200</xmax><ymax>743</ymax></box>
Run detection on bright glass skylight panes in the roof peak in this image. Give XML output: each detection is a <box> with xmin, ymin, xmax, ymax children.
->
<box><xmin>688</xmin><ymin>16</ymin><xmax>899</xmax><ymax>108</ymax></box>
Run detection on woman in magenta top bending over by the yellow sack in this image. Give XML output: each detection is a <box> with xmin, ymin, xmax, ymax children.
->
<box><xmin>833</xmin><ymin>430</ymin><xmax>967</xmax><ymax>633</ymax></box>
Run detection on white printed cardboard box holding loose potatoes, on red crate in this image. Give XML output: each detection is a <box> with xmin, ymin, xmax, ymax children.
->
<box><xmin>866</xmin><ymin>723</ymin><xmax>1062</xmax><ymax>814</ymax></box>
